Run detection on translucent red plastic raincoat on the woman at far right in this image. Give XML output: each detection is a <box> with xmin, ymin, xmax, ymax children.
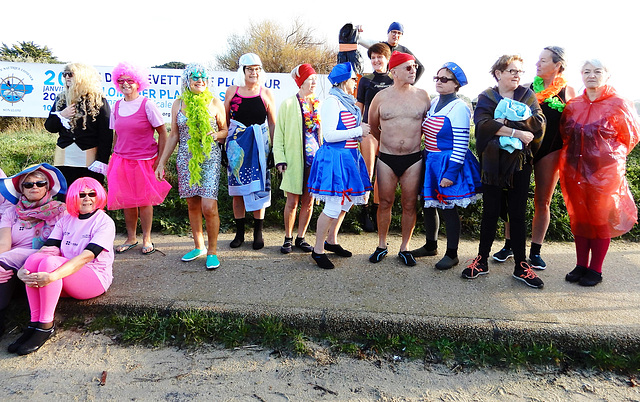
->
<box><xmin>560</xmin><ymin>86</ymin><xmax>640</xmax><ymax>239</ymax></box>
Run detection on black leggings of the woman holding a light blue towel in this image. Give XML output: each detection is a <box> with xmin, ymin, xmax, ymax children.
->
<box><xmin>478</xmin><ymin>164</ymin><xmax>531</xmax><ymax>265</ymax></box>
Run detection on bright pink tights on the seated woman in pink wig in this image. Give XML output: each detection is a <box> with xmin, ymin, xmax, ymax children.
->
<box><xmin>24</xmin><ymin>253</ymin><xmax>105</xmax><ymax>322</ymax></box>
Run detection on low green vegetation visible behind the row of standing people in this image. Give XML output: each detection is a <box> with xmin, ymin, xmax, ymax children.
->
<box><xmin>0</xmin><ymin>125</ymin><xmax>640</xmax><ymax>242</ymax></box>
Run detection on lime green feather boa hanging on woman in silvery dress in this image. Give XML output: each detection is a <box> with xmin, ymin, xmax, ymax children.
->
<box><xmin>181</xmin><ymin>88</ymin><xmax>215</xmax><ymax>186</ymax></box>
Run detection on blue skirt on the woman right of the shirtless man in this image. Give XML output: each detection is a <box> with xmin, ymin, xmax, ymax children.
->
<box><xmin>422</xmin><ymin>150</ymin><xmax>482</xmax><ymax>209</ymax></box>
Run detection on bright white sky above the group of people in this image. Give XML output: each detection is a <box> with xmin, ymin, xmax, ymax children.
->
<box><xmin>5</xmin><ymin>0</ymin><xmax>640</xmax><ymax>100</ymax></box>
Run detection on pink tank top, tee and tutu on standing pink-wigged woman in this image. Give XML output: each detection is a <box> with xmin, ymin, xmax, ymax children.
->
<box><xmin>107</xmin><ymin>96</ymin><xmax>171</xmax><ymax>210</ymax></box>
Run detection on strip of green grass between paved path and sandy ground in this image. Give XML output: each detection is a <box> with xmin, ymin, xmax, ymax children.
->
<box><xmin>30</xmin><ymin>306</ymin><xmax>640</xmax><ymax>375</ymax></box>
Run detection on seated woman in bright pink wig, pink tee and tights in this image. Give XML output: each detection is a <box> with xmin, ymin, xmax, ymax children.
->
<box><xmin>8</xmin><ymin>177</ymin><xmax>116</xmax><ymax>355</ymax></box>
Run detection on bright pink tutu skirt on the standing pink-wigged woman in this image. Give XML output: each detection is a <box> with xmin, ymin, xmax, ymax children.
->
<box><xmin>107</xmin><ymin>154</ymin><xmax>171</xmax><ymax>210</ymax></box>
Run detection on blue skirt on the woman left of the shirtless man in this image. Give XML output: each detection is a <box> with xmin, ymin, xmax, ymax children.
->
<box><xmin>307</xmin><ymin>141</ymin><xmax>372</xmax><ymax>205</ymax></box>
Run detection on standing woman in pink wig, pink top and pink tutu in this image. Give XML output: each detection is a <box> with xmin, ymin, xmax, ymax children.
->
<box><xmin>107</xmin><ymin>63</ymin><xmax>171</xmax><ymax>255</ymax></box>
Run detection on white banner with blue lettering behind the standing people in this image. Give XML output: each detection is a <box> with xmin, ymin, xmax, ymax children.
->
<box><xmin>0</xmin><ymin>62</ymin><xmax>331</xmax><ymax>123</ymax></box>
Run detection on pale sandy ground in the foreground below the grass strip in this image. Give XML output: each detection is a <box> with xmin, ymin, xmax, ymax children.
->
<box><xmin>0</xmin><ymin>331</ymin><xmax>640</xmax><ymax>401</ymax></box>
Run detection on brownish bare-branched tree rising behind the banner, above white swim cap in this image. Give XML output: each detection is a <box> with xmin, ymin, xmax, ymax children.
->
<box><xmin>216</xmin><ymin>20</ymin><xmax>337</xmax><ymax>74</ymax></box>
